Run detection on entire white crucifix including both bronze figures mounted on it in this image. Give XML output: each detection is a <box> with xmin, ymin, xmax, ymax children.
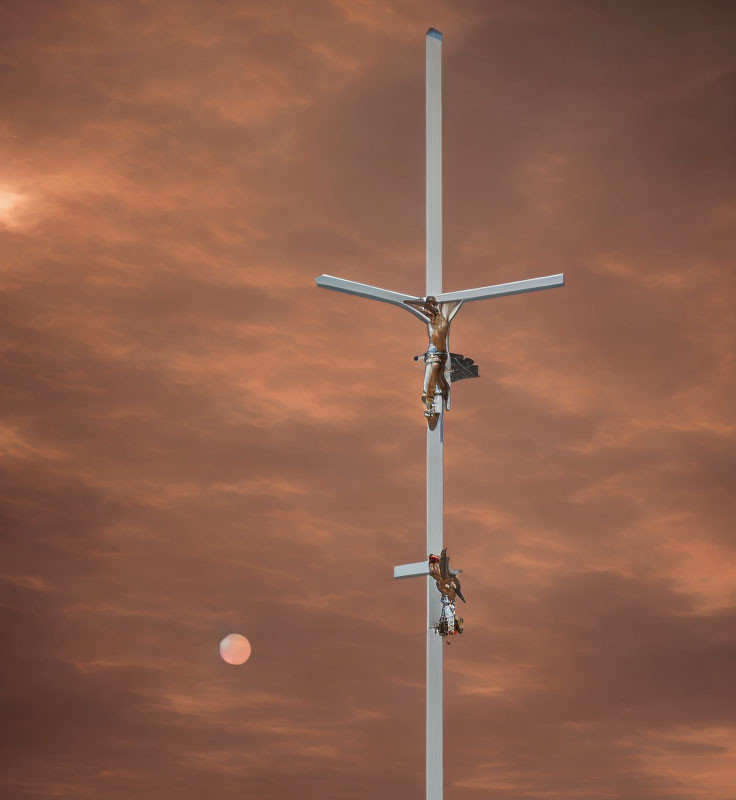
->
<box><xmin>315</xmin><ymin>28</ymin><xmax>565</xmax><ymax>800</ymax></box>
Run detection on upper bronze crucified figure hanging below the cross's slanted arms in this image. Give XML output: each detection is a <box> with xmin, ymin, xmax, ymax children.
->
<box><xmin>404</xmin><ymin>295</ymin><xmax>462</xmax><ymax>431</ymax></box>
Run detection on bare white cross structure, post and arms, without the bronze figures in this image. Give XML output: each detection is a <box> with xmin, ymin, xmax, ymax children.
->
<box><xmin>315</xmin><ymin>28</ymin><xmax>565</xmax><ymax>800</ymax></box>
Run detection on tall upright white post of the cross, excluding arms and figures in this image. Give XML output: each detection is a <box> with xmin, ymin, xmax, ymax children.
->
<box><xmin>426</xmin><ymin>28</ymin><xmax>444</xmax><ymax>800</ymax></box>
